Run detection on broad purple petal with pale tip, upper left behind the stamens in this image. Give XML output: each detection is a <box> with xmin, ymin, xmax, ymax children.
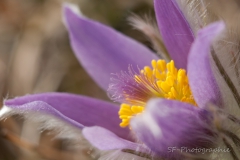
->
<box><xmin>64</xmin><ymin>6</ymin><xmax>158</xmax><ymax>90</ymax></box>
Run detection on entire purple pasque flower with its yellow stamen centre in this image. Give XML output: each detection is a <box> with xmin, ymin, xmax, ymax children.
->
<box><xmin>2</xmin><ymin>0</ymin><xmax>240</xmax><ymax>159</ymax></box>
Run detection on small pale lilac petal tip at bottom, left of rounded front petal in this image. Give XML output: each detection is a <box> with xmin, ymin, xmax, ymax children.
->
<box><xmin>83</xmin><ymin>126</ymin><xmax>144</xmax><ymax>151</ymax></box>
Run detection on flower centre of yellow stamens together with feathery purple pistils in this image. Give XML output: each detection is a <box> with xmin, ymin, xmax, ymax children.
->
<box><xmin>109</xmin><ymin>60</ymin><xmax>196</xmax><ymax>127</ymax></box>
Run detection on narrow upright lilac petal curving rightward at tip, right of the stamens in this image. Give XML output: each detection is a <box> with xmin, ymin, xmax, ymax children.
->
<box><xmin>188</xmin><ymin>22</ymin><xmax>225</xmax><ymax>107</ymax></box>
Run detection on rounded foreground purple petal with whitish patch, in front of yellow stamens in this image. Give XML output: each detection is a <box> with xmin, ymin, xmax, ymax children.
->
<box><xmin>131</xmin><ymin>99</ymin><xmax>215</xmax><ymax>159</ymax></box>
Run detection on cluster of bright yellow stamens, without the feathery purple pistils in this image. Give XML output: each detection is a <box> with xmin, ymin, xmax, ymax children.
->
<box><xmin>119</xmin><ymin>60</ymin><xmax>197</xmax><ymax>127</ymax></box>
